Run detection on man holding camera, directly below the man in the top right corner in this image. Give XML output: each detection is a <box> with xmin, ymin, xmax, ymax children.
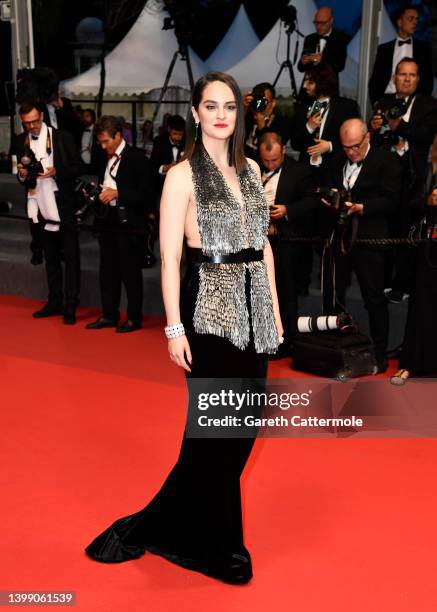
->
<box><xmin>370</xmin><ymin>57</ymin><xmax>437</xmax><ymax>303</ymax></box>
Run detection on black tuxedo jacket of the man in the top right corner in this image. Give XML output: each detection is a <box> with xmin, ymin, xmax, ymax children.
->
<box><xmin>369</xmin><ymin>39</ymin><xmax>434</xmax><ymax>104</ymax></box>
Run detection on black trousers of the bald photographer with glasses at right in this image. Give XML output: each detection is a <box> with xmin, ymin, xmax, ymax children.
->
<box><xmin>323</xmin><ymin>247</ymin><xmax>389</xmax><ymax>359</ymax></box>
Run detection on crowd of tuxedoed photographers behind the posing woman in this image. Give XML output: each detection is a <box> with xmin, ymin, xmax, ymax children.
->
<box><xmin>12</xmin><ymin>7</ymin><xmax>437</xmax><ymax>372</ymax></box>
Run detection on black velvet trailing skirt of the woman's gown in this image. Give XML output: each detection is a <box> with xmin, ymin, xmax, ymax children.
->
<box><xmin>86</xmin><ymin>264</ymin><xmax>267</xmax><ymax>577</ymax></box>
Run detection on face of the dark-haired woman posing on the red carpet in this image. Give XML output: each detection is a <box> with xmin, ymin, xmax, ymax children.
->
<box><xmin>192</xmin><ymin>81</ymin><xmax>237</xmax><ymax>140</ymax></box>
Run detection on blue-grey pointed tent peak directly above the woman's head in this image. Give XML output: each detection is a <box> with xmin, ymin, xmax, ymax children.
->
<box><xmin>205</xmin><ymin>4</ymin><xmax>259</xmax><ymax>72</ymax></box>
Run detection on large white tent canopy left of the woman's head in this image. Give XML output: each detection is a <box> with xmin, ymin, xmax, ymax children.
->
<box><xmin>61</xmin><ymin>8</ymin><xmax>207</xmax><ymax>96</ymax></box>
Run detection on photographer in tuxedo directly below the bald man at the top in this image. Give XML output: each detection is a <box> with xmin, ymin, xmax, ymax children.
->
<box><xmin>291</xmin><ymin>64</ymin><xmax>360</xmax><ymax>181</ymax></box>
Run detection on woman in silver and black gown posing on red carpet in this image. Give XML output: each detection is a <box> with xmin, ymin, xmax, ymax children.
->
<box><xmin>86</xmin><ymin>73</ymin><xmax>283</xmax><ymax>584</ymax></box>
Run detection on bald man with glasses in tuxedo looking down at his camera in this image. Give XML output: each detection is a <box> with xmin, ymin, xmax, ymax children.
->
<box><xmin>324</xmin><ymin>119</ymin><xmax>401</xmax><ymax>372</ymax></box>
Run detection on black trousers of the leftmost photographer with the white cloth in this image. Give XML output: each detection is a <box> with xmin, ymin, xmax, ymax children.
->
<box><xmin>41</xmin><ymin>227</ymin><xmax>80</xmax><ymax>307</ymax></box>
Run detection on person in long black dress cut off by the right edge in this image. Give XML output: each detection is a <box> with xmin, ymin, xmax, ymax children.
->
<box><xmin>390</xmin><ymin>136</ymin><xmax>437</xmax><ymax>385</ymax></box>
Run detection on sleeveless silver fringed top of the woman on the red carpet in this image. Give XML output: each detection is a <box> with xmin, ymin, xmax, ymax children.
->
<box><xmin>190</xmin><ymin>147</ymin><xmax>279</xmax><ymax>353</ymax></box>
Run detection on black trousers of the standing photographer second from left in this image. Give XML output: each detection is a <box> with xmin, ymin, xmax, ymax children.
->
<box><xmin>99</xmin><ymin>227</ymin><xmax>144</xmax><ymax>323</ymax></box>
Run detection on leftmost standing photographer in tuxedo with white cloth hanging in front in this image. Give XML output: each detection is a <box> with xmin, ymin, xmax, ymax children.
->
<box><xmin>15</xmin><ymin>103</ymin><xmax>82</xmax><ymax>325</ymax></box>
